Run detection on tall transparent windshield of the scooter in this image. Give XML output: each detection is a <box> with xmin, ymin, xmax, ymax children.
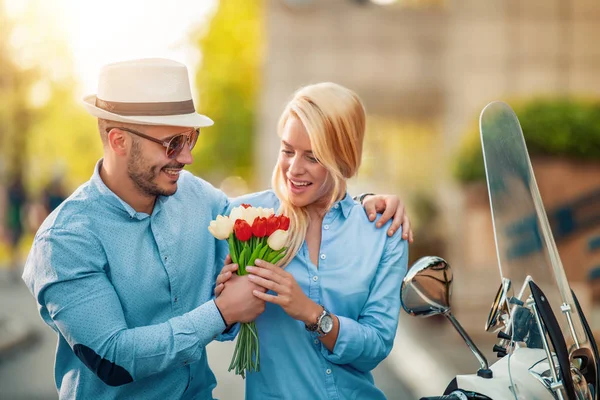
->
<box><xmin>480</xmin><ymin>102</ymin><xmax>591</xmax><ymax>358</ymax></box>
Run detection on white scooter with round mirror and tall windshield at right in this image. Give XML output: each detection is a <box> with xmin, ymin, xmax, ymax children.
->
<box><xmin>401</xmin><ymin>102</ymin><xmax>600</xmax><ymax>400</ymax></box>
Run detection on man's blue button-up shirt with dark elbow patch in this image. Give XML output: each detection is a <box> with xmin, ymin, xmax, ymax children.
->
<box><xmin>23</xmin><ymin>160</ymin><xmax>228</xmax><ymax>399</ymax></box>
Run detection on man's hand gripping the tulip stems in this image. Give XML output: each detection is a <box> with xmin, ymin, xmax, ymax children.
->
<box><xmin>215</xmin><ymin>274</ymin><xmax>265</xmax><ymax>326</ymax></box>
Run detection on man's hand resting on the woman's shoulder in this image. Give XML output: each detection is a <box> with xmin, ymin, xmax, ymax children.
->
<box><xmin>363</xmin><ymin>194</ymin><xmax>414</xmax><ymax>243</ymax></box>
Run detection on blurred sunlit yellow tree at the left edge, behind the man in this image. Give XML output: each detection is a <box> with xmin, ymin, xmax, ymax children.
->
<box><xmin>0</xmin><ymin>0</ymin><xmax>102</xmax><ymax>194</ymax></box>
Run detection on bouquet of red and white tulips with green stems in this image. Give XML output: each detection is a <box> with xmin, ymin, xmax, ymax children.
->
<box><xmin>208</xmin><ymin>204</ymin><xmax>290</xmax><ymax>378</ymax></box>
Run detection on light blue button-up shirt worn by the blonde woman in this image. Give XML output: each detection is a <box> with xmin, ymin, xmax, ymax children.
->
<box><xmin>232</xmin><ymin>191</ymin><xmax>408</xmax><ymax>400</ymax></box>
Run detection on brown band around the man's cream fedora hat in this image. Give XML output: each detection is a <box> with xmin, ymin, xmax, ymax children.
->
<box><xmin>96</xmin><ymin>98</ymin><xmax>196</xmax><ymax>115</ymax></box>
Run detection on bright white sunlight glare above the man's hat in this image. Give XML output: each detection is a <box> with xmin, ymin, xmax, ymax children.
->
<box><xmin>57</xmin><ymin>0</ymin><xmax>217</xmax><ymax>95</ymax></box>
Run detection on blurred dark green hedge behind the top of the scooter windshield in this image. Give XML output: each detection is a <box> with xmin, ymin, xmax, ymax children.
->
<box><xmin>454</xmin><ymin>98</ymin><xmax>600</xmax><ymax>183</ymax></box>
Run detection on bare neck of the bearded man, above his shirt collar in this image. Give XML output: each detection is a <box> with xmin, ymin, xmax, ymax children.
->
<box><xmin>100</xmin><ymin>161</ymin><xmax>156</xmax><ymax>214</ymax></box>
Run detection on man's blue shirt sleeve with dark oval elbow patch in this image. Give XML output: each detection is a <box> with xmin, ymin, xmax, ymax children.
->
<box><xmin>24</xmin><ymin>229</ymin><xmax>225</xmax><ymax>386</ymax></box>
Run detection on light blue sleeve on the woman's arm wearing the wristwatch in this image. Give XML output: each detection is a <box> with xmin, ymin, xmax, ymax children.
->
<box><xmin>321</xmin><ymin>228</ymin><xmax>408</xmax><ymax>371</ymax></box>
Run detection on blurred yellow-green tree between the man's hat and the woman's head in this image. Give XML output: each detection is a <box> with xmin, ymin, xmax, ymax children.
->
<box><xmin>190</xmin><ymin>0</ymin><xmax>265</xmax><ymax>187</ymax></box>
